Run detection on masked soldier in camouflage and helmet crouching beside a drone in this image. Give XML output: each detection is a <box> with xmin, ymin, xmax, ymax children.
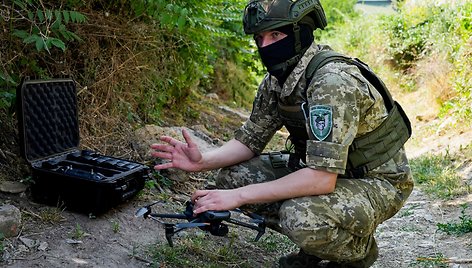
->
<box><xmin>151</xmin><ymin>0</ymin><xmax>413</xmax><ymax>267</ymax></box>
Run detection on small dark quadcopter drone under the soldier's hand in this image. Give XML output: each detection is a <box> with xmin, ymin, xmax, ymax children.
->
<box><xmin>135</xmin><ymin>201</ymin><xmax>266</xmax><ymax>247</ymax></box>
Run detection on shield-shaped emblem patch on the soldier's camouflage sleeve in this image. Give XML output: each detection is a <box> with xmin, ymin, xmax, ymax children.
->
<box><xmin>310</xmin><ymin>105</ymin><xmax>333</xmax><ymax>141</ymax></box>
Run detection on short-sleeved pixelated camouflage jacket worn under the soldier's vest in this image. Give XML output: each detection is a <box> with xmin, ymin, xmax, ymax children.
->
<box><xmin>235</xmin><ymin>44</ymin><xmax>406</xmax><ymax>174</ymax></box>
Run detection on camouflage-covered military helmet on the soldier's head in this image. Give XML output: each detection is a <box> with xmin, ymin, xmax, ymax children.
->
<box><xmin>243</xmin><ymin>0</ymin><xmax>327</xmax><ymax>34</ymax></box>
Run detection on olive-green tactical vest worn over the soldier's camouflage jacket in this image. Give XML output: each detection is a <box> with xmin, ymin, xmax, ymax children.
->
<box><xmin>278</xmin><ymin>50</ymin><xmax>411</xmax><ymax>178</ymax></box>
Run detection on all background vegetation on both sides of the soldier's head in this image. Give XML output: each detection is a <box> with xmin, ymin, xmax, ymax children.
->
<box><xmin>0</xmin><ymin>0</ymin><xmax>472</xmax><ymax>137</ymax></box>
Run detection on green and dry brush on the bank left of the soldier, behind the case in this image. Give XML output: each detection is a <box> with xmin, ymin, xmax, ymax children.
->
<box><xmin>0</xmin><ymin>0</ymin><xmax>258</xmax><ymax>117</ymax></box>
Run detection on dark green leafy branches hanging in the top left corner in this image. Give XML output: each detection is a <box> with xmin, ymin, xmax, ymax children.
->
<box><xmin>0</xmin><ymin>0</ymin><xmax>87</xmax><ymax>109</ymax></box>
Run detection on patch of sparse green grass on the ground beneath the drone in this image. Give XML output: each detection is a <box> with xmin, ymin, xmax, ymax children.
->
<box><xmin>138</xmin><ymin>215</ymin><xmax>298</xmax><ymax>268</ymax></box>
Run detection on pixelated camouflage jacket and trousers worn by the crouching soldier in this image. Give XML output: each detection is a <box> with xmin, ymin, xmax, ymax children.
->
<box><xmin>216</xmin><ymin>44</ymin><xmax>413</xmax><ymax>262</ymax></box>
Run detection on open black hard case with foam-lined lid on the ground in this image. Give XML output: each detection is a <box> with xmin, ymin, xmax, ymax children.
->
<box><xmin>17</xmin><ymin>79</ymin><xmax>149</xmax><ymax>214</ymax></box>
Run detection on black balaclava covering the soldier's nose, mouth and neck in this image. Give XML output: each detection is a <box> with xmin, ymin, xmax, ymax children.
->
<box><xmin>258</xmin><ymin>24</ymin><xmax>313</xmax><ymax>86</ymax></box>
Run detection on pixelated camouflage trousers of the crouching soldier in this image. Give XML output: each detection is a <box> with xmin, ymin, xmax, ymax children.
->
<box><xmin>215</xmin><ymin>155</ymin><xmax>413</xmax><ymax>262</ymax></box>
